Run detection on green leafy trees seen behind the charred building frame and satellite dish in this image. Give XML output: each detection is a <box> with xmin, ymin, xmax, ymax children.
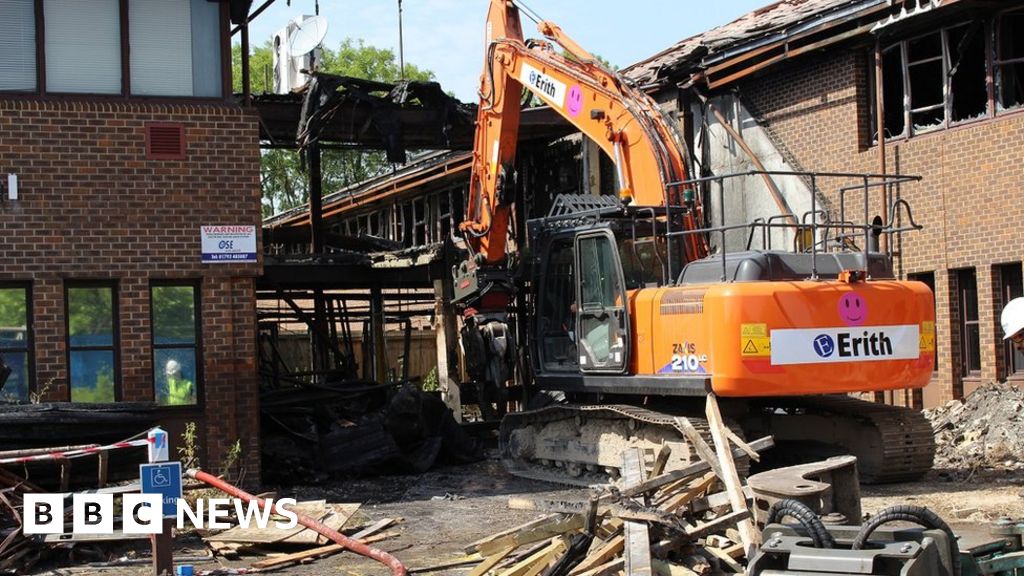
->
<box><xmin>231</xmin><ymin>39</ymin><xmax>434</xmax><ymax>216</ymax></box>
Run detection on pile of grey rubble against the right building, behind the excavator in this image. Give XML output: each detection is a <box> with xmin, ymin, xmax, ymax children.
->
<box><xmin>925</xmin><ymin>382</ymin><xmax>1024</xmax><ymax>470</ymax></box>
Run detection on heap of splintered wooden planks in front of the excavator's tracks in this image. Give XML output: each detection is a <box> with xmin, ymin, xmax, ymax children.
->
<box><xmin>430</xmin><ymin>400</ymin><xmax>771</xmax><ymax>576</ymax></box>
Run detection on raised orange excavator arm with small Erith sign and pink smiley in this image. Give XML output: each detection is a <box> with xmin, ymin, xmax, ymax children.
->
<box><xmin>460</xmin><ymin>0</ymin><xmax>706</xmax><ymax>264</ymax></box>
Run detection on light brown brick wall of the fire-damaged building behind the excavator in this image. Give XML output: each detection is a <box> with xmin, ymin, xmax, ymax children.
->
<box><xmin>739</xmin><ymin>49</ymin><xmax>1024</xmax><ymax>405</ymax></box>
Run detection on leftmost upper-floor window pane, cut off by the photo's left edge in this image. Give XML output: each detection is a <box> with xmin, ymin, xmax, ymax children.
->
<box><xmin>0</xmin><ymin>0</ymin><xmax>36</xmax><ymax>91</ymax></box>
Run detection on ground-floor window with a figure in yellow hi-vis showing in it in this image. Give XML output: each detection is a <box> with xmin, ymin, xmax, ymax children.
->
<box><xmin>150</xmin><ymin>284</ymin><xmax>202</xmax><ymax>406</ymax></box>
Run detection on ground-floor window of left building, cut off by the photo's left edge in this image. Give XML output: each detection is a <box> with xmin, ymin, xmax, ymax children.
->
<box><xmin>0</xmin><ymin>286</ymin><xmax>32</xmax><ymax>402</ymax></box>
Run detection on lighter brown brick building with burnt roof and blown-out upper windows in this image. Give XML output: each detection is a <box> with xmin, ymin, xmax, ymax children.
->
<box><xmin>626</xmin><ymin>0</ymin><xmax>1024</xmax><ymax>406</ymax></box>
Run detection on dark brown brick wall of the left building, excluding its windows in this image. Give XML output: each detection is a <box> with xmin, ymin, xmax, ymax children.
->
<box><xmin>0</xmin><ymin>98</ymin><xmax>262</xmax><ymax>482</ymax></box>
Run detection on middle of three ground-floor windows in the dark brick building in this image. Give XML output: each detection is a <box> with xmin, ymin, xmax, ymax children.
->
<box><xmin>67</xmin><ymin>284</ymin><xmax>120</xmax><ymax>402</ymax></box>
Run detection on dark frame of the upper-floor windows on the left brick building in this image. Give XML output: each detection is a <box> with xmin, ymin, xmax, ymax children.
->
<box><xmin>0</xmin><ymin>0</ymin><xmax>228</xmax><ymax>104</ymax></box>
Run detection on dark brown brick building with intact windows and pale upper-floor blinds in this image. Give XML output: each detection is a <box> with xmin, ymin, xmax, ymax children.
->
<box><xmin>0</xmin><ymin>0</ymin><xmax>262</xmax><ymax>482</ymax></box>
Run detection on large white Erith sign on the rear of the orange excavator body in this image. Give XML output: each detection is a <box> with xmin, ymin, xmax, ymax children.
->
<box><xmin>771</xmin><ymin>325</ymin><xmax>921</xmax><ymax>365</ymax></box>
